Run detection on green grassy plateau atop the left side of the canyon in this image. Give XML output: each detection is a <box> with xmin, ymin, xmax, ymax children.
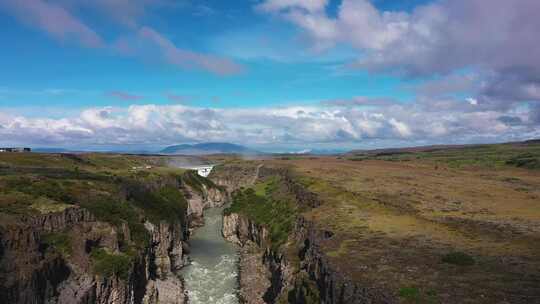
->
<box><xmin>0</xmin><ymin>153</ymin><xmax>221</xmax><ymax>250</ymax></box>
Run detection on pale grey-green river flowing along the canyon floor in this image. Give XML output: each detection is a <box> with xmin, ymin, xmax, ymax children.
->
<box><xmin>182</xmin><ymin>208</ymin><xmax>239</xmax><ymax>304</ymax></box>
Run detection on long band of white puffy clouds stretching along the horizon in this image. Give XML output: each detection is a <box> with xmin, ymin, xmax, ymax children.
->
<box><xmin>0</xmin><ymin>101</ymin><xmax>540</xmax><ymax>146</ymax></box>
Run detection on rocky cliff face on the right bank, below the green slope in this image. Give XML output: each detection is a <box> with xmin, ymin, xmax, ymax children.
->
<box><xmin>217</xmin><ymin>168</ymin><xmax>398</xmax><ymax>304</ymax></box>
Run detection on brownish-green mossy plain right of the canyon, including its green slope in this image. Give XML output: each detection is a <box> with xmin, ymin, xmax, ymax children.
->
<box><xmin>219</xmin><ymin>143</ymin><xmax>540</xmax><ymax>303</ymax></box>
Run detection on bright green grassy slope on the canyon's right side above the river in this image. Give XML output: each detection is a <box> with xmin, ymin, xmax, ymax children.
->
<box><xmin>225</xmin><ymin>178</ymin><xmax>297</xmax><ymax>247</ymax></box>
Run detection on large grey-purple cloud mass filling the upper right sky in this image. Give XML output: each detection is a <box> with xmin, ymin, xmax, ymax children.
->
<box><xmin>257</xmin><ymin>0</ymin><xmax>540</xmax><ymax>108</ymax></box>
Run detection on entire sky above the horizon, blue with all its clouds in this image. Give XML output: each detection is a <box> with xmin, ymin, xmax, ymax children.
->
<box><xmin>0</xmin><ymin>0</ymin><xmax>540</xmax><ymax>151</ymax></box>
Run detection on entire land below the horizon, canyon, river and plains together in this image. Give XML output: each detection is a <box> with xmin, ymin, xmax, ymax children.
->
<box><xmin>0</xmin><ymin>143</ymin><xmax>540</xmax><ymax>304</ymax></box>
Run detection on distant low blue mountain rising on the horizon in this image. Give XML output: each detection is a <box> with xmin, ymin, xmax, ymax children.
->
<box><xmin>160</xmin><ymin>143</ymin><xmax>260</xmax><ymax>155</ymax></box>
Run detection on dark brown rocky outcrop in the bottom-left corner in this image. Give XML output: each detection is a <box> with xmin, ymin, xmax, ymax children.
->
<box><xmin>0</xmin><ymin>208</ymin><xmax>93</xmax><ymax>303</ymax></box>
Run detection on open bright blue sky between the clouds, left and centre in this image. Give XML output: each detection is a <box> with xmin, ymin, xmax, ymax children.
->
<box><xmin>0</xmin><ymin>1</ymin><xmax>412</xmax><ymax>108</ymax></box>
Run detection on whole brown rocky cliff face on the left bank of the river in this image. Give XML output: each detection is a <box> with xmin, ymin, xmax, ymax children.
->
<box><xmin>0</xmin><ymin>173</ymin><xmax>227</xmax><ymax>304</ymax></box>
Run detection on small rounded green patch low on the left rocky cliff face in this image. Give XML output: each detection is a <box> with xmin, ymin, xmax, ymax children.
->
<box><xmin>90</xmin><ymin>248</ymin><xmax>132</xmax><ymax>280</ymax></box>
